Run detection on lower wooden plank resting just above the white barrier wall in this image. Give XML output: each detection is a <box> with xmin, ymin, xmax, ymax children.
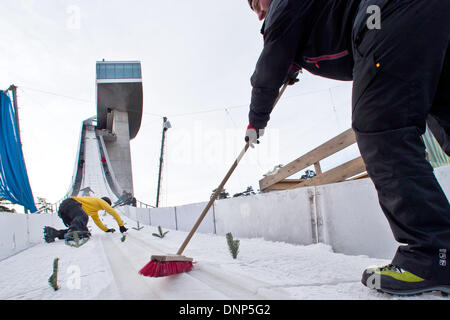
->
<box><xmin>289</xmin><ymin>157</ymin><xmax>366</xmax><ymax>189</ymax></box>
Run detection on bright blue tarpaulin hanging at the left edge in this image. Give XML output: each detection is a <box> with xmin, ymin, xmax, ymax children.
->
<box><xmin>0</xmin><ymin>91</ymin><xmax>37</xmax><ymax>212</ymax></box>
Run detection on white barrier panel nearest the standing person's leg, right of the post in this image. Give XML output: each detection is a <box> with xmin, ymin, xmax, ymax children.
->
<box><xmin>316</xmin><ymin>179</ymin><xmax>399</xmax><ymax>258</ymax></box>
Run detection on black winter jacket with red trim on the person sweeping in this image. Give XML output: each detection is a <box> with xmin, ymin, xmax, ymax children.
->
<box><xmin>249</xmin><ymin>0</ymin><xmax>361</xmax><ymax>129</ymax></box>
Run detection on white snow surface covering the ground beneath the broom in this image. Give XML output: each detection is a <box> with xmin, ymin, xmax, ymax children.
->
<box><xmin>0</xmin><ymin>215</ymin><xmax>446</xmax><ymax>300</ymax></box>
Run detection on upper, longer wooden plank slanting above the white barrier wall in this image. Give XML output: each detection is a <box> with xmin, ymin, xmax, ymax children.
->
<box><xmin>259</xmin><ymin>128</ymin><xmax>356</xmax><ymax>191</ymax></box>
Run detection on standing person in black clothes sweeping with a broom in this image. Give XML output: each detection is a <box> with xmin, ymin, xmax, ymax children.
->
<box><xmin>245</xmin><ymin>0</ymin><xmax>450</xmax><ymax>295</ymax></box>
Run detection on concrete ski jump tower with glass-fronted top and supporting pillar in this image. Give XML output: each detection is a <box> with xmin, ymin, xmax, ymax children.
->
<box><xmin>96</xmin><ymin>60</ymin><xmax>143</xmax><ymax>194</ymax></box>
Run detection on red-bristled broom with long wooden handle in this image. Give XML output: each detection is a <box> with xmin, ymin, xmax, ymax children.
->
<box><xmin>139</xmin><ymin>80</ymin><xmax>289</xmax><ymax>278</ymax></box>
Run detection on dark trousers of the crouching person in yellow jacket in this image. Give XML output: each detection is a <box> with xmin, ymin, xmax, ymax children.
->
<box><xmin>58</xmin><ymin>198</ymin><xmax>89</xmax><ymax>238</ymax></box>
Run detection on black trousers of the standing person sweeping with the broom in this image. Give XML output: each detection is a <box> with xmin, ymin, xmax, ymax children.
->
<box><xmin>352</xmin><ymin>0</ymin><xmax>450</xmax><ymax>284</ymax></box>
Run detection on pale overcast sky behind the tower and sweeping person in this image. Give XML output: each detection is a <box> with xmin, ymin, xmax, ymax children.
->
<box><xmin>0</xmin><ymin>0</ymin><xmax>357</xmax><ymax>206</ymax></box>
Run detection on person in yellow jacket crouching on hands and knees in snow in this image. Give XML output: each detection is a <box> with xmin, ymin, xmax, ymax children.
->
<box><xmin>44</xmin><ymin>197</ymin><xmax>128</xmax><ymax>243</ymax></box>
